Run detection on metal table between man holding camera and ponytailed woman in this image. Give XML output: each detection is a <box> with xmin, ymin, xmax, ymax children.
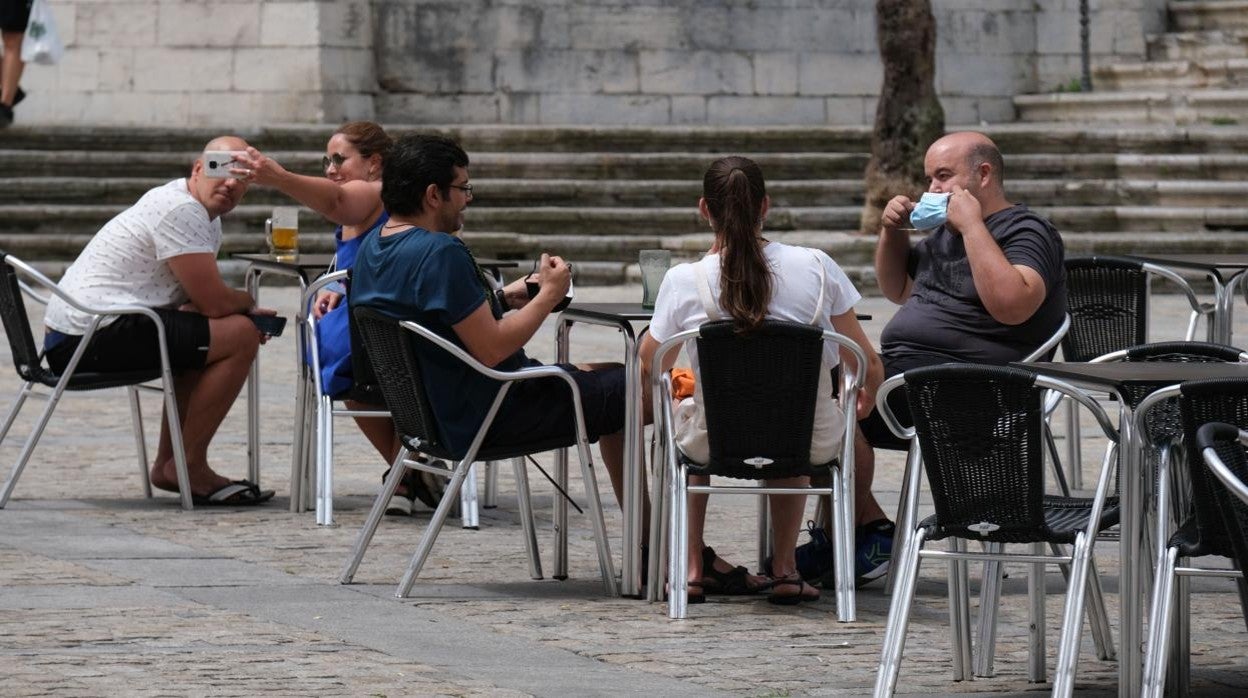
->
<box><xmin>554</xmin><ymin>303</ymin><xmax>654</xmax><ymax>597</ymax></box>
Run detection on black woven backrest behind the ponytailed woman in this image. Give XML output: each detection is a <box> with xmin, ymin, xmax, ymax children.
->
<box><xmin>698</xmin><ymin>320</ymin><xmax>824</xmax><ymax>479</ymax></box>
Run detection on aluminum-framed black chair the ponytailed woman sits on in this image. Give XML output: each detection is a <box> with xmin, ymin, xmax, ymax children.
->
<box><xmin>650</xmin><ymin>320</ymin><xmax>866</xmax><ymax>622</ymax></box>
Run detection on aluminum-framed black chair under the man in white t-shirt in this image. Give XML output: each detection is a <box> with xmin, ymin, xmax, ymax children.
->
<box><xmin>0</xmin><ymin>255</ymin><xmax>193</xmax><ymax>509</ymax></box>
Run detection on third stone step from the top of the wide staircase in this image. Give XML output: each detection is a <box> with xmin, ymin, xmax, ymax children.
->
<box><xmin>7</xmin><ymin>176</ymin><xmax>1248</xmax><ymax>208</ymax></box>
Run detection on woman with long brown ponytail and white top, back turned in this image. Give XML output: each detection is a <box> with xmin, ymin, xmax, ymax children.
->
<box><xmin>640</xmin><ymin>157</ymin><xmax>884</xmax><ymax>604</ymax></box>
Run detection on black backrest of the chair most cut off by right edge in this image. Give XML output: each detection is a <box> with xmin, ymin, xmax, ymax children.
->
<box><xmin>1196</xmin><ymin>422</ymin><xmax>1248</xmax><ymax>634</ymax></box>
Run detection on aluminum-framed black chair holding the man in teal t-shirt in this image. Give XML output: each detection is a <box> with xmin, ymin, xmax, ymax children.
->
<box><xmin>339</xmin><ymin>307</ymin><xmax>619</xmax><ymax>598</ymax></box>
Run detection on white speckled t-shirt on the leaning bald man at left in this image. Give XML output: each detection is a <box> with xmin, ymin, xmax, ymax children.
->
<box><xmin>44</xmin><ymin>179</ymin><xmax>221</xmax><ymax>335</ymax></box>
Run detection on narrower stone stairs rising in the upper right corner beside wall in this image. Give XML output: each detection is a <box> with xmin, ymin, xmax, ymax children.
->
<box><xmin>1015</xmin><ymin>0</ymin><xmax>1248</xmax><ymax>125</ymax></box>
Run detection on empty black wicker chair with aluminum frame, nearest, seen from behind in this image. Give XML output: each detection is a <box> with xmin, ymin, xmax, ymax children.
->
<box><xmin>875</xmin><ymin>365</ymin><xmax>1118</xmax><ymax>696</ymax></box>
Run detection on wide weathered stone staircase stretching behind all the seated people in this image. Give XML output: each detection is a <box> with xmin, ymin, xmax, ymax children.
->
<box><xmin>0</xmin><ymin>124</ymin><xmax>1248</xmax><ymax>292</ymax></box>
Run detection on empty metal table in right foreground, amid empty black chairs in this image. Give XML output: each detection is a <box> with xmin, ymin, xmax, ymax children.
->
<box><xmin>1012</xmin><ymin>361</ymin><xmax>1248</xmax><ymax>698</ymax></box>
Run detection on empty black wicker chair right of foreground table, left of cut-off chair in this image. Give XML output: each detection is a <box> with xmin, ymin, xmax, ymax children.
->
<box><xmin>1142</xmin><ymin>378</ymin><xmax>1248</xmax><ymax>696</ymax></box>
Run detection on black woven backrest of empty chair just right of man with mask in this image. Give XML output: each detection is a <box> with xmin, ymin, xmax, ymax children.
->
<box><xmin>1062</xmin><ymin>256</ymin><xmax>1148</xmax><ymax>361</ymax></box>
